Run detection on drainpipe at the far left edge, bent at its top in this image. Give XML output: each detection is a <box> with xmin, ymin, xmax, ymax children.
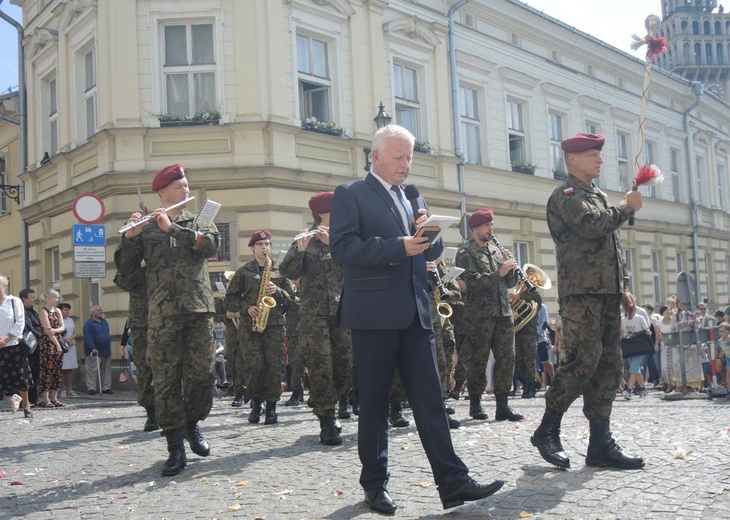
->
<box><xmin>0</xmin><ymin>0</ymin><xmax>30</xmax><ymax>289</ymax></box>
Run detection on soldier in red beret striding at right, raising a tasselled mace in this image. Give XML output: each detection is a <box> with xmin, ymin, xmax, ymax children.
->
<box><xmin>531</xmin><ymin>134</ymin><xmax>644</xmax><ymax>469</ymax></box>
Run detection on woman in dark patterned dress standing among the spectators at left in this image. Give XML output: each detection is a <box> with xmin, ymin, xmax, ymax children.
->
<box><xmin>37</xmin><ymin>289</ymin><xmax>66</xmax><ymax>408</ymax></box>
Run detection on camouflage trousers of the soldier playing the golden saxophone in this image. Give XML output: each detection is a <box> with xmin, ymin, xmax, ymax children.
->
<box><xmin>241</xmin><ymin>325</ymin><xmax>284</xmax><ymax>401</ymax></box>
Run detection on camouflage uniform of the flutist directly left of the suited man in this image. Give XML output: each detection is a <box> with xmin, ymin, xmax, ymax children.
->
<box><xmin>281</xmin><ymin>237</ymin><xmax>352</xmax><ymax>417</ymax></box>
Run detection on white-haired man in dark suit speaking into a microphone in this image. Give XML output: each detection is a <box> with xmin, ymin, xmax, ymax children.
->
<box><xmin>330</xmin><ymin>125</ymin><xmax>504</xmax><ymax>514</ymax></box>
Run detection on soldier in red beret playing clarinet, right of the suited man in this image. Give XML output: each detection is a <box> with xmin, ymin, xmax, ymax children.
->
<box><xmin>456</xmin><ymin>209</ymin><xmax>523</xmax><ymax>421</ymax></box>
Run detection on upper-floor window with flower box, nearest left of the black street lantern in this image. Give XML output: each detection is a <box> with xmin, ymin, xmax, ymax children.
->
<box><xmin>297</xmin><ymin>34</ymin><xmax>332</xmax><ymax>121</ymax></box>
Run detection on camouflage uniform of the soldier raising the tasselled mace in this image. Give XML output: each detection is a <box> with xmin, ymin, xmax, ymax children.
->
<box><xmin>545</xmin><ymin>175</ymin><xmax>634</xmax><ymax>420</ymax></box>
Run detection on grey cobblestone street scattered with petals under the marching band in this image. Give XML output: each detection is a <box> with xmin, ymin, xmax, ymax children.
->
<box><xmin>0</xmin><ymin>392</ymin><xmax>730</xmax><ymax>520</ymax></box>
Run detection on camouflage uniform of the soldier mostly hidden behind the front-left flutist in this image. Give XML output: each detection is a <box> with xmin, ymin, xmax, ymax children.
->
<box><xmin>114</xmin><ymin>244</ymin><xmax>155</xmax><ymax>408</ymax></box>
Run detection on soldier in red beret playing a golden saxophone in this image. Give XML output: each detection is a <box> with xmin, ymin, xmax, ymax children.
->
<box><xmin>226</xmin><ymin>229</ymin><xmax>295</xmax><ymax>424</ymax></box>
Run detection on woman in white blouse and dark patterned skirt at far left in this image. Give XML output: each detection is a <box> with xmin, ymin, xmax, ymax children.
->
<box><xmin>0</xmin><ymin>275</ymin><xmax>33</xmax><ymax>419</ymax></box>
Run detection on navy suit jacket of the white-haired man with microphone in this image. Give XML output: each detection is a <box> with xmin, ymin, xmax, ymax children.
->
<box><xmin>329</xmin><ymin>174</ymin><xmax>443</xmax><ymax>329</ymax></box>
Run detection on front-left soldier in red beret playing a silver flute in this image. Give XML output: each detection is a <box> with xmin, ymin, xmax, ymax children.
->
<box><xmin>115</xmin><ymin>164</ymin><xmax>220</xmax><ymax>476</ymax></box>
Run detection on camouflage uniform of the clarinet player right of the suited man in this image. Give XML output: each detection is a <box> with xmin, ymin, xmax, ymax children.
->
<box><xmin>456</xmin><ymin>239</ymin><xmax>517</xmax><ymax>395</ymax></box>
